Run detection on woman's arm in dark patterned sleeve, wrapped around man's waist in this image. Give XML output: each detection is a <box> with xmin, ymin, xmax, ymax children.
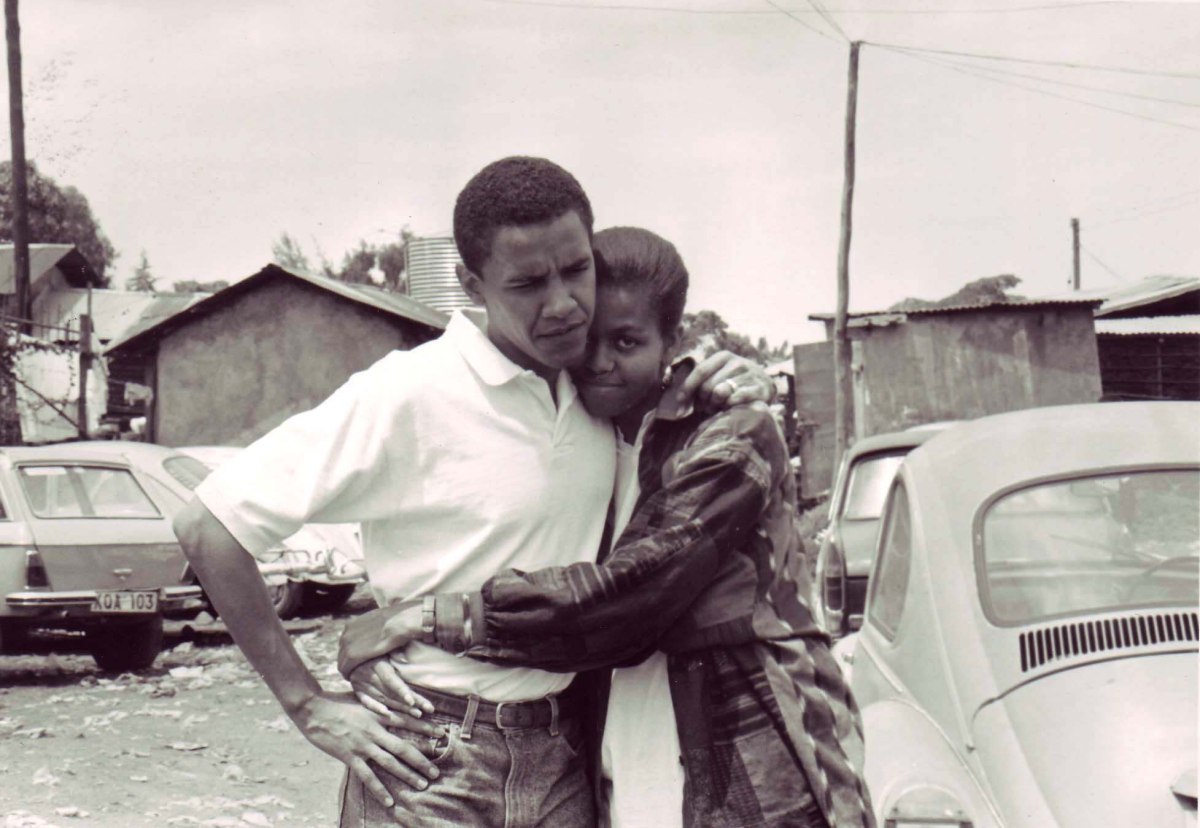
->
<box><xmin>338</xmin><ymin>409</ymin><xmax>787</xmax><ymax>676</ymax></box>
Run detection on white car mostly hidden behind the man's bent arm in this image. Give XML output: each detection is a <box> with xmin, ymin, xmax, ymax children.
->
<box><xmin>175</xmin><ymin>445</ymin><xmax>366</xmax><ymax>618</ymax></box>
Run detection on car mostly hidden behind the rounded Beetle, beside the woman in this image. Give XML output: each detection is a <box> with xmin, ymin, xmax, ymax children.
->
<box><xmin>812</xmin><ymin>421</ymin><xmax>954</xmax><ymax>638</ymax></box>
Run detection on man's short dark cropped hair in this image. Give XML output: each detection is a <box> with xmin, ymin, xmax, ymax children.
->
<box><xmin>454</xmin><ymin>156</ymin><xmax>592</xmax><ymax>276</ymax></box>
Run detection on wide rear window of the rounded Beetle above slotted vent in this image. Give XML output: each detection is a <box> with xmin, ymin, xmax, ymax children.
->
<box><xmin>982</xmin><ymin>469</ymin><xmax>1200</xmax><ymax>623</ymax></box>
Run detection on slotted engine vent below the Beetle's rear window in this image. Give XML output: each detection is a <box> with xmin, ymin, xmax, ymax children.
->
<box><xmin>1021</xmin><ymin>612</ymin><xmax>1200</xmax><ymax>673</ymax></box>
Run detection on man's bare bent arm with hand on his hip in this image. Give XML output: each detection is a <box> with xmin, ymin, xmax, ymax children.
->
<box><xmin>174</xmin><ymin>499</ymin><xmax>438</xmax><ymax>806</ymax></box>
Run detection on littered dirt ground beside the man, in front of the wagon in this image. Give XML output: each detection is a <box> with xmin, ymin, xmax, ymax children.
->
<box><xmin>0</xmin><ymin>592</ymin><xmax>371</xmax><ymax>828</ymax></box>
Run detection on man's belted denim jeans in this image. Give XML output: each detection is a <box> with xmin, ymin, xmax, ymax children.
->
<box><xmin>338</xmin><ymin>691</ymin><xmax>595</xmax><ymax>828</ymax></box>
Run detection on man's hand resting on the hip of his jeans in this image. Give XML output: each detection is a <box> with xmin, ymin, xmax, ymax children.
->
<box><xmin>289</xmin><ymin>691</ymin><xmax>440</xmax><ymax>808</ymax></box>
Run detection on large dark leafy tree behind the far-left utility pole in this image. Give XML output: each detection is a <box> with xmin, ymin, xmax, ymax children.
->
<box><xmin>0</xmin><ymin>161</ymin><xmax>116</xmax><ymax>287</ymax></box>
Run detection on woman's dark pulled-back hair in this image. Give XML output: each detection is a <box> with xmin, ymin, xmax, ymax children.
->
<box><xmin>592</xmin><ymin>227</ymin><xmax>688</xmax><ymax>337</ymax></box>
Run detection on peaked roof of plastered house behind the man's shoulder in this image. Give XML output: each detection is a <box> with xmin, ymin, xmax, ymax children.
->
<box><xmin>106</xmin><ymin>264</ymin><xmax>449</xmax><ymax>353</ymax></box>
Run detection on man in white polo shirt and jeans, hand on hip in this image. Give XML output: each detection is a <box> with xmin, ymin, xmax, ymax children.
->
<box><xmin>175</xmin><ymin>157</ymin><xmax>763</xmax><ymax>828</ymax></box>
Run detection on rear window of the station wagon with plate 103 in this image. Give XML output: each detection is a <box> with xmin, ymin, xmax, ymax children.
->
<box><xmin>19</xmin><ymin>466</ymin><xmax>160</xmax><ymax>520</ymax></box>
